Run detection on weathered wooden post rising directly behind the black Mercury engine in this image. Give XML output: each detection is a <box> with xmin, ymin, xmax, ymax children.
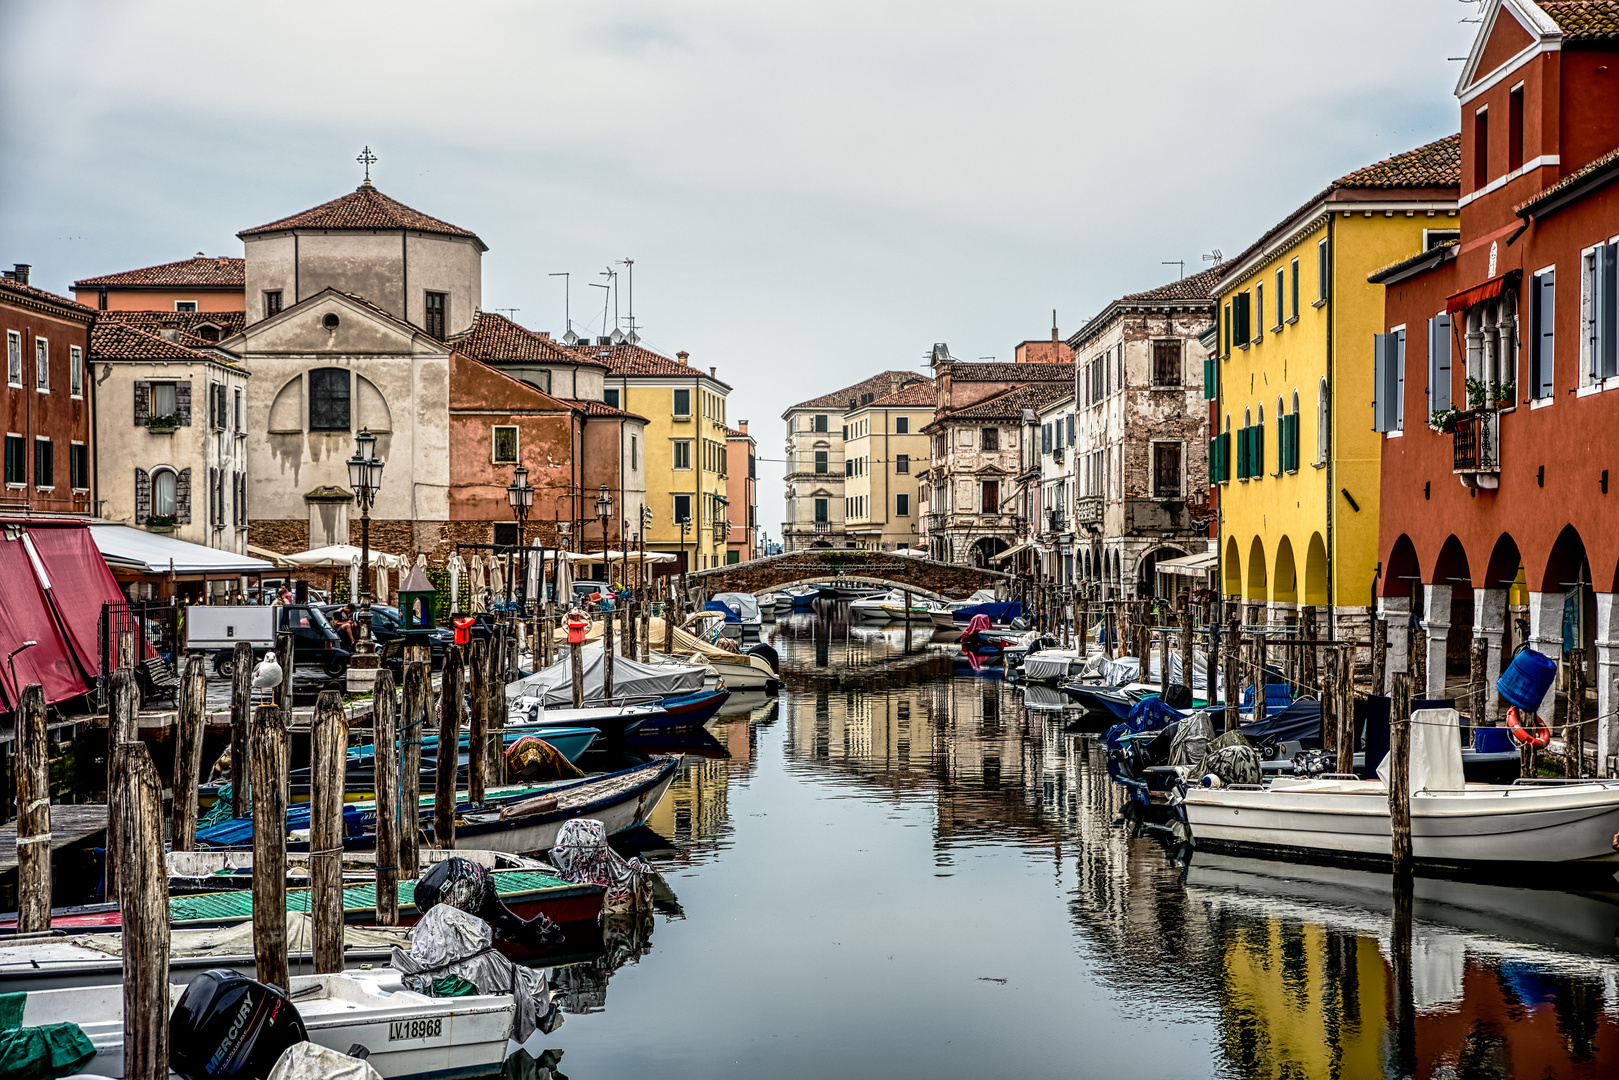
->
<box><xmin>252</xmin><ymin>704</ymin><xmax>287</xmax><ymax>1002</ymax></box>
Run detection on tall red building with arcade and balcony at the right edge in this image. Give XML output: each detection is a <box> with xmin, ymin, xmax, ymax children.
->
<box><xmin>1371</xmin><ymin>0</ymin><xmax>1619</xmax><ymax>772</ymax></box>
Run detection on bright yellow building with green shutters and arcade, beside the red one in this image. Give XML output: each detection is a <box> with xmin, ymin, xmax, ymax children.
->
<box><xmin>1209</xmin><ymin>136</ymin><xmax>1460</xmax><ymax>636</ymax></box>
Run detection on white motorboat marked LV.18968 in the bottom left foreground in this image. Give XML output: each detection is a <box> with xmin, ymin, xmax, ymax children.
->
<box><xmin>23</xmin><ymin>968</ymin><xmax>516</xmax><ymax>1077</ymax></box>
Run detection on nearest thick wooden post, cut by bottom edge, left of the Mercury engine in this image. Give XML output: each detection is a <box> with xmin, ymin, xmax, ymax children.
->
<box><xmin>115</xmin><ymin>742</ymin><xmax>168</xmax><ymax>1080</ymax></box>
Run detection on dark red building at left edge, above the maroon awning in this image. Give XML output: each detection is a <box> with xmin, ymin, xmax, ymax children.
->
<box><xmin>0</xmin><ymin>264</ymin><xmax>96</xmax><ymax>515</ymax></box>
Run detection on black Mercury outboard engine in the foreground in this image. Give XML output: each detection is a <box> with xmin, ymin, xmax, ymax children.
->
<box><xmin>168</xmin><ymin>968</ymin><xmax>309</xmax><ymax>1080</ymax></box>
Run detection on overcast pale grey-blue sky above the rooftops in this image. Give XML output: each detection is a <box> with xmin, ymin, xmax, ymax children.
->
<box><xmin>0</xmin><ymin>0</ymin><xmax>1478</xmax><ymax>536</ymax></box>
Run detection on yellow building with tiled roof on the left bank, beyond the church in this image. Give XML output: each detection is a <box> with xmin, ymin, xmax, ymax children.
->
<box><xmin>592</xmin><ymin>343</ymin><xmax>731</xmax><ymax>570</ymax></box>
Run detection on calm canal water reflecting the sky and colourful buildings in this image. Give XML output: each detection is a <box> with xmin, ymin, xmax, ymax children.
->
<box><xmin>549</xmin><ymin>610</ymin><xmax>1619</xmax><ymax>1080</ymax></box>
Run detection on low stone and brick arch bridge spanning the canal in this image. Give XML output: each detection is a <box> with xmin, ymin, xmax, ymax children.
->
<box><xmin>688</xmin><ymin>547</ymin><xmax>1012</xmax><ymax>601</ymax></box>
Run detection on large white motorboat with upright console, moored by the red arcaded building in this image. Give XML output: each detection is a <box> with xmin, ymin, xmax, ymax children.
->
<box><xmin>1185</xmin><ymin>709</ymin><xmax>1619</xmax><ymax>878</ymax></box>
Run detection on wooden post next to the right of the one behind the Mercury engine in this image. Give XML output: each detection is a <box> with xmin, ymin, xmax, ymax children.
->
<box><xmin>309</xmin><ymin>690</ymin><xmax>348</xmax><ymax>975</ymax></box>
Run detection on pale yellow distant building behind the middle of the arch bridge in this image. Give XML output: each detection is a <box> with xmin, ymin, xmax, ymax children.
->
<box><xmin>843</xmin><ymin>379</ymin><xmax>934</xmax><ymax>551</ymax></box>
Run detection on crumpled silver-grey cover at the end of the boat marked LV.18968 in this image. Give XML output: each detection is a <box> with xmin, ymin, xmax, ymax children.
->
<box><xmin>390</xmin><ymin>904</ymin><xmax>562</xmax><ymax>1043</ymax></box>
